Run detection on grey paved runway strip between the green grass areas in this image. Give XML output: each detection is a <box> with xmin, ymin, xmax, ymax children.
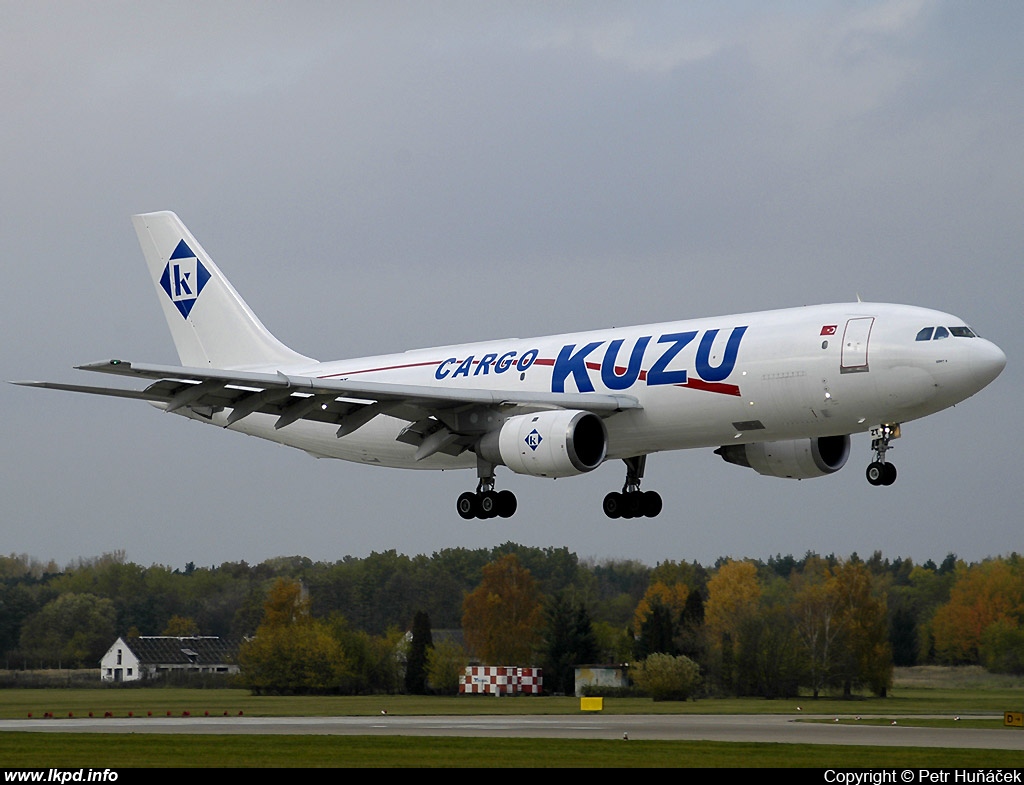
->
<box><xmin>0</xmin><ymin>714</ymin><xmax>1024</xmax><ymax>749</ymax></box>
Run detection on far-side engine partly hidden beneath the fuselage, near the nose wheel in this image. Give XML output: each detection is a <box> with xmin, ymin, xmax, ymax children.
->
<box><xmin>715</xmin><ymin>435</ymin><xmax>850</xmax><ymax>480</ymax></box>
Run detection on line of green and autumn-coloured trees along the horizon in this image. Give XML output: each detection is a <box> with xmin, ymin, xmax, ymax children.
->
<box><xmin>0</xmin><ymin>542</ymin><xmax>1024</xmax><ymax>697</ymax></box>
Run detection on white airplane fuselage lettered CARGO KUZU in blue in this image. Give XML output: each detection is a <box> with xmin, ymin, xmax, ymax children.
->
<box><xmin>190</xmin><ymin>303</ymin><xmax>1006</xmax><ymax>469</ymax></box>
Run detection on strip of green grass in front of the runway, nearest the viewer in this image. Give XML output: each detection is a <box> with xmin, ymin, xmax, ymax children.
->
<box><xmin>0</xmin><ymin>733</ymin><xmax>1024</xmax><ymax>769</ymax></box>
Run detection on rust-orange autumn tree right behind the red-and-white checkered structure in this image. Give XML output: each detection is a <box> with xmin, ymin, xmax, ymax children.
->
<box><xmin>462</xmin><ymin>554</ymin><xmax>544</xmax><ymax>664</ymax></box>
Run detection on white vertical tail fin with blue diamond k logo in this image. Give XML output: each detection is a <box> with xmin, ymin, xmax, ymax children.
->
<box><xmin>132</xmin><ymin>212</ymin><xmax>314</xmax><ymax>368</ymax></box>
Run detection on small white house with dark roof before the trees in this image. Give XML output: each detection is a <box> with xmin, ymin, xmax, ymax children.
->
<box><xmin>99</xmin><ymin>636</ymin><xmax>239</xmax><ymax>682</ymax></box>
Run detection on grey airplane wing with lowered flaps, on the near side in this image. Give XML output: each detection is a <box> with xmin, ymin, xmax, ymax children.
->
<box><xmin>14</xmin><ymin>360</ymin><xmax>641</xmax><ymax>459</ymax></box>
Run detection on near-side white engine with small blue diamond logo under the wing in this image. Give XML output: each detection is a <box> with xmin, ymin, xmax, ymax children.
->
<box><xmin>477</xmin><ymin>409</ymin><xmax>608</xmax><ymax>477</ymax></box>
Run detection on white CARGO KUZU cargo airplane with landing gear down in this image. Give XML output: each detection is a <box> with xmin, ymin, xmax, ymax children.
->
<box><xmin>13</xmin><ymin>212</ymin><xmax>1007</xmax><ymax>520</ymax></box>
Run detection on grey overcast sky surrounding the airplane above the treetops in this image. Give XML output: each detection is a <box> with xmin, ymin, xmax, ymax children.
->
<box><xmin>0</xmin><ymin>0</ymin><xmax>1024</xmax><ymax>567</ymax></box>
